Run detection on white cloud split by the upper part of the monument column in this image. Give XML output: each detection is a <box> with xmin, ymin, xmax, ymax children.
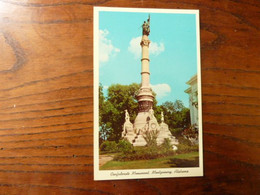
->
<box><xmin>128</xmin><ymin>36</ymin><xmax>165</xmax><ymax>59</ymax></box>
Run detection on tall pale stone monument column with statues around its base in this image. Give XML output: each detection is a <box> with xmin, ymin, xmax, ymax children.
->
<box><xmin>122</xmin><ymin>16</ymin><xmax>178</xmax><ymax>146</ymax></box>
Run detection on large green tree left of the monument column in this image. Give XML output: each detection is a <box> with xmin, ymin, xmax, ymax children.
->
<box><xmin>99</xmin><ymin>83</ymin><xmax>140</xmax><ymax>141</ymax></box>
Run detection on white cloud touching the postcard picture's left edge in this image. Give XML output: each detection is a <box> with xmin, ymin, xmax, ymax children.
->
<box><xmin>99</xmin><ymin>29</ymin><xmax>120</xmax><ymax>62</ymax></box>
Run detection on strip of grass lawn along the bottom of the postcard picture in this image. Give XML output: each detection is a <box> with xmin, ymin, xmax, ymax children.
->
<box><xmin>100</xmin><ymin>152</ymin><xmax>199</xmax><ymax>170</ymax></box>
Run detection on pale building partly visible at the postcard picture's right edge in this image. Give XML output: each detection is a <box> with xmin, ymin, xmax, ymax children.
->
<box><xmin>185</xmin><ymin>74</ymin><xmax>198</xmax><ymax>127</ymax></box>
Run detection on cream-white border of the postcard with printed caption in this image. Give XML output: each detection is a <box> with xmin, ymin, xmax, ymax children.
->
<box><xmin>93</xmin><ymin>7</ymin><xmax>203</xmax><ymax>180</ymax></box>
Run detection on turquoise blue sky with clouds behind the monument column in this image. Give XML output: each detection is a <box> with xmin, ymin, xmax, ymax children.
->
<box><xmin>99</xmin><ymin>11</ymin><xmax>197</xmax><ymax>107</ymax></box>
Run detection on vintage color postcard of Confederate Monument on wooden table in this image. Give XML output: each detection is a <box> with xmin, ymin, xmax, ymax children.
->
<box><xmin>94</xmin><ymin>7</ymin><xmax>203</xmax><ymax>180</ymax></box>
